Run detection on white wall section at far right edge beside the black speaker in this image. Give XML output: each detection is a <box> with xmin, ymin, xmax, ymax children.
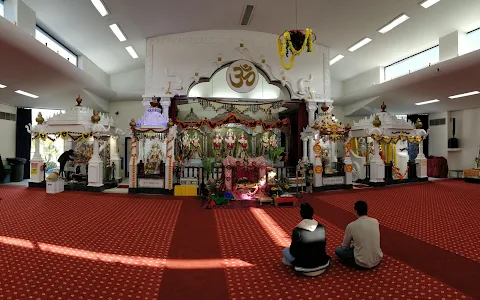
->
<box><xmin>448</xmin><ymin>108</ymin><xmax>480</xmax><ymax>169</ymax></box>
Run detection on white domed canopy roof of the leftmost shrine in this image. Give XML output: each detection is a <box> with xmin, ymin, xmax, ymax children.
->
<box><xmin>26</xmin><ymin>97</ymin><xmax>120</xmax><ymax>141</ymax></box>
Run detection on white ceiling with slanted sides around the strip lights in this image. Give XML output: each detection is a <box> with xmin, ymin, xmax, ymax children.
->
<box><xmin>23</xmin><ymin>0</ymin><xmax>480</xmax><ymax>80</ymax></box>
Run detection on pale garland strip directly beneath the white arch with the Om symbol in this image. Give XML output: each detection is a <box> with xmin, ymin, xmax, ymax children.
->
<box><xmin>197</xmin><ymin>97</ymin><xmax>283</xmax><ymax>113</ymax></box>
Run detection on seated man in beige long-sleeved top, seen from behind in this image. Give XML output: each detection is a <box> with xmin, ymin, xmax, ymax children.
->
<box><xmin>335</xmin><ymin>201</ymin><xmax>383</xmax><ymax>269</ymax></box>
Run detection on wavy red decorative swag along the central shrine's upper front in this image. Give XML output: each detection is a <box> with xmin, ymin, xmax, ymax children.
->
<box><xmin>177</xmin><ymin>113</ymin><xmax>290</xmax><ymax>132</ymax></box>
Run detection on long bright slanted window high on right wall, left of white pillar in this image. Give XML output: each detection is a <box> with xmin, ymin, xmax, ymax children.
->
<box><xmin>385</xmin><ymin>46</ymin><xmax>440</xmax><ymax>81</ymax></box>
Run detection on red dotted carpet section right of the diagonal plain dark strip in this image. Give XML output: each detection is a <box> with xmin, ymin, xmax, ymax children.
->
<box><xmin>315</xmin><ymin>180</ymin><xmax>480</xmax><ymax>262</ymax></box>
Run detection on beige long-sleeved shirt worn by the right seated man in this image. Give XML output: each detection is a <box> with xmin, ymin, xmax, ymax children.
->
<box><xmin>342</xmin><ymin>216</ymin><xmax>383</xmax><ymax>268</ymax></box>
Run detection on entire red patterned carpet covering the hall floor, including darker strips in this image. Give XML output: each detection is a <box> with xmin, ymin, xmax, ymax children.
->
<box><xmin>0</xmin><ymin>181</ymin><xmax>480</xmax><ymax>300</ymax></box>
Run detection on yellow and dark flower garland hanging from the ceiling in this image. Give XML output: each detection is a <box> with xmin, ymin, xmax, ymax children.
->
<box><xmin>277</xmin><ymin>28</ymin><xmax>314</xmax><ymax>70</ymax></box>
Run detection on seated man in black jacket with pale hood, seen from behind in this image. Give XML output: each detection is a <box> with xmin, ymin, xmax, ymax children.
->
<box><xmin>282</xmin><ymin>203</ymin><xmax>330</xmax><ymax>276</ymax></box>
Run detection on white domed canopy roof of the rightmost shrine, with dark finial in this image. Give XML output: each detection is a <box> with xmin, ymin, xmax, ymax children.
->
<box><xmin>350</xmin><ymin>104</ymin><xmax>415</xmax><ymax>141</ymax></box>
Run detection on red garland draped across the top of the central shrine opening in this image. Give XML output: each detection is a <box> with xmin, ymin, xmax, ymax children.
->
<box><xmin>177</xmin><ymin>114</ymin><xmax>290</xmax><ymax>131</ymax></box>
